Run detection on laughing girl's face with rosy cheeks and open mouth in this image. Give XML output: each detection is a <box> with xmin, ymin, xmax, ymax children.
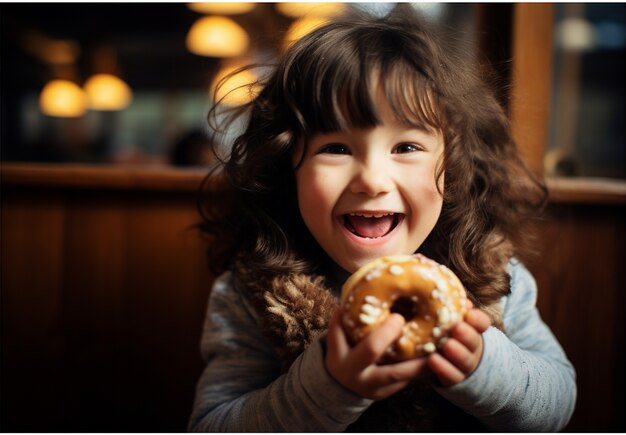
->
<box><xmin>296</xmin><ymin>93</ymin><xmax>444</xmax><ymax>273</ymax></box>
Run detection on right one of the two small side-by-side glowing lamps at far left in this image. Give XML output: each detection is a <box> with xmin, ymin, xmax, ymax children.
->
<box><xmin>85</xmin><ymin>74</ymin><xmax>133</xmax><ymax>110</ymax></box>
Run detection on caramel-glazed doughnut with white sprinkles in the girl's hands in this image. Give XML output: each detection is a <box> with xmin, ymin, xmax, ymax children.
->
<box><xmin>341</xmin><ymin>254</ymin><xmax>470</xmax><ymax>362</ymax></box>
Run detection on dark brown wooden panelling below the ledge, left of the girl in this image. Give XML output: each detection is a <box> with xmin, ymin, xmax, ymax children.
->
<box><xmin>2</xmin><ymin>178</ymin><xmax>213</xmax><ymax>432</ymax></box>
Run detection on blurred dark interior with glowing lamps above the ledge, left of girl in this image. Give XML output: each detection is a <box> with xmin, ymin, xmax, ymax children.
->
<box><xmin>2</xmin><ymin>3</ymin><xmax>474</xmax><ymax>169</ymax></box>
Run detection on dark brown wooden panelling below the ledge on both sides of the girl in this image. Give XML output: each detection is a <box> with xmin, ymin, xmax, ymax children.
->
<box><xmin>1</xmin><ymin>164</ymin><xmax>626</xmax><ymax>432</ymax></box>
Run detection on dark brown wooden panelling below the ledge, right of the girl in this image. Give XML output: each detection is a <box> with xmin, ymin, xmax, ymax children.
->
<box><xmin>529</xmin><ymin>204</ymin><xmax>626</xmax><ymax>432</ymax></box>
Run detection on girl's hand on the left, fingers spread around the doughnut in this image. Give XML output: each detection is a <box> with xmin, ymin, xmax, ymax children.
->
<box><xmin>326</xmin><ymin>309</ymin><xmax>429</xmax><ymax>400</ymax></box>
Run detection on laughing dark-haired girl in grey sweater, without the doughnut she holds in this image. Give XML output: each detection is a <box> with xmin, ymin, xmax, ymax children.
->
<box><xmin>189</xmin><ymin>9</ymin><xmax>576</xmax><ymax>432</ymax></box>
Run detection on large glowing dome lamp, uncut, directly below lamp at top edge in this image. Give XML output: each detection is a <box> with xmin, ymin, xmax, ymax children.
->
<box><xmin>187</xmin><ymin>16</ymin><xmax>249</xmax><ymax>57</ymax></box>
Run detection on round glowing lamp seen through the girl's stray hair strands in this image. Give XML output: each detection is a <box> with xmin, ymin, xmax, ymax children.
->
<box><xmin>210</xmin><ymin>66</ymin><xmax>260</xmax><ymax>106</ymax></box>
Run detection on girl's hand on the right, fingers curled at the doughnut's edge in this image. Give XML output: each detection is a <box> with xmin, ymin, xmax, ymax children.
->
<box><xmin>428</xmin><ymin>308</ymin><xmax>491</xmax><ymax>386</ymax></box>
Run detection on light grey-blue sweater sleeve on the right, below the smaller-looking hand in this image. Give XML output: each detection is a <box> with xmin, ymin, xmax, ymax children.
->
<box><xmin>437</xmin><ymin>261</ymin><xmax>576</xmax><ymax>432</ymax></box>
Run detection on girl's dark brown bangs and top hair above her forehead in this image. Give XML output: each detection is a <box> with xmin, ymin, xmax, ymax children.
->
<box><xmin>285</xmin><ymin>22</ymin><xmax>443</xmax><ymax>138</ymax></box>
